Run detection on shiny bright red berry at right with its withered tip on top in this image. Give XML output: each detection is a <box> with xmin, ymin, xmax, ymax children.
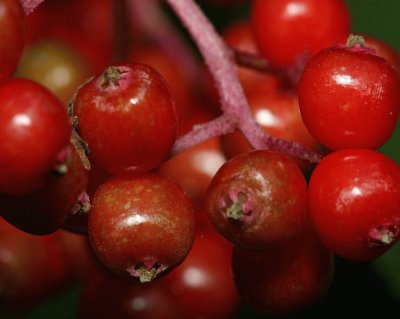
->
<box><xmin>298</xmin><ymin>46</ymin><xmax>400</xmax><ymax>150</ymax></box>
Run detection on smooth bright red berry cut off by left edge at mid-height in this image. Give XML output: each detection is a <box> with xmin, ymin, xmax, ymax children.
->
<box><xmin>0</xmin><ymin>79</ymin><xmax>71</xmax><ymax>195</ymax></box>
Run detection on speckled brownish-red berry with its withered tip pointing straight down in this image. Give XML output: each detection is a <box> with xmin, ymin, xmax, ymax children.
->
<box><xmin>88</xmin><ymin>174</ymin><xmax>195</xmax><ymax>282</ymax></box>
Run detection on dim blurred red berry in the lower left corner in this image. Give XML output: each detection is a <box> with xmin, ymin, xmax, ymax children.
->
<box><xmin>0</xmin><ymin>219</ymin><xmax>71</xmax><ymax>318</ymax></box>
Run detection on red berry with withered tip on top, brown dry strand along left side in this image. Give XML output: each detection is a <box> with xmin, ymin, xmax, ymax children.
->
<box><xmin>74</xmin><ymin>64</ymin><xmax>177</xmax><ymax>174</ymax></box>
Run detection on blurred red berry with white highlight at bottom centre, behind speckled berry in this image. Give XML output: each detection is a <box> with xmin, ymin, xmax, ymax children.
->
<box><xmin>164</xmin><ymin>231</ymin><xmax>239</xmax><ymax>319</ymax></box>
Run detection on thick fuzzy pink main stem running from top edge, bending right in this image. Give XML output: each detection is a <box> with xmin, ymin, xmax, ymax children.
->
<box><xmin>167</xmin><ymin>0</ymin><xmax>321</xmax><ymax>162</ymax></box>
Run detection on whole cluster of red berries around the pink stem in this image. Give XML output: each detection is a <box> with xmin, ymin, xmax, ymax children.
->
<box><xmin>0</xmin><ymin>0</ymin><xmax>400</xmax><ymax>319</ymax></box>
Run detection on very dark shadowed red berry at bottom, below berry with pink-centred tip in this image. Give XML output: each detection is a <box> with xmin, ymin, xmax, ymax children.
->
<box><xmin>232</xmin><ymin>225</ymin><xmax>333</xmax><ymax>318</ymax></box>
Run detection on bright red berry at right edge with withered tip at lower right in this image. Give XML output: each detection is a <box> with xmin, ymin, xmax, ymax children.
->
<box><xmin>309</xmin><ymin>149</ymin><xmax>400</xmax><ymax>261</ymax></box>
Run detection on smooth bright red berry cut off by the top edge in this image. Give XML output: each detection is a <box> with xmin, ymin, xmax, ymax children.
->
<box><xmin>251</xmin><ymin>0</ymin><xmax>350</xmax><ymax>66</ymax></box>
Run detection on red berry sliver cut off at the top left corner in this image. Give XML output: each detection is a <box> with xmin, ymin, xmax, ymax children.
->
<box><xmin>0</xmin><ymin>0</ymin><xmax>25</xmax><ymax>80</ymax></box>
